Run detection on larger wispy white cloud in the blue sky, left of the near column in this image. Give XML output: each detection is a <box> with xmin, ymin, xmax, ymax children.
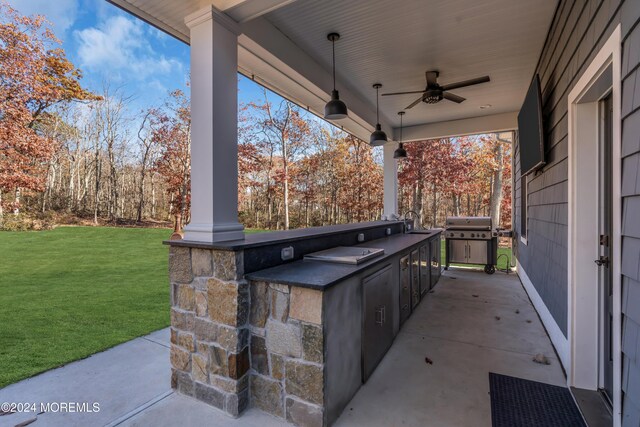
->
<box><xmin>75</xmin><ymin>16</ymin><xmax>183</xmax><ymax>80</ymax></box>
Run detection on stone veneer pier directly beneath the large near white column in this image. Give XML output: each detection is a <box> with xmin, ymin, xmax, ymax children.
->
<box><xmin>169</xmin><ymin>247</ymin><xmax>250</xmax><ymax>417</ymax></box>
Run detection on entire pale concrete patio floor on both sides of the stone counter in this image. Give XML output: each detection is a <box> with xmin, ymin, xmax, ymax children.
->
<box><xmin>0</xmin><ymin>269</ymin><xmax>565</xmax><ymax>427</ymax></box>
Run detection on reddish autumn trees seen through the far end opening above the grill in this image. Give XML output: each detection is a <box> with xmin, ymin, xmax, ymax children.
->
<box><xmin>398</xmin><ymin>132</ymin><xmax>513</xmax><ymax>228</ymax></box>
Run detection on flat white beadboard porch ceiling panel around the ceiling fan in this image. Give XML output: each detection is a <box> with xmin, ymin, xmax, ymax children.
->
<box><xmin>266</xmin><ymin>0</ymin><xmax>557</xmax><ymax>130</ymax></box>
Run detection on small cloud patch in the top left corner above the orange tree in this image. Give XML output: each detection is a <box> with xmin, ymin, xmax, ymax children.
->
<box><xmin>9</xmin><ymin>0</ymin><xmax>78</xmax><ymax>37</ymax></box>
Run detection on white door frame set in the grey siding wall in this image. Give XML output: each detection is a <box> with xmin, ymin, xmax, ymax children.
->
<box><xmin>566</xmin><ymin>25</ymin><xmax>622</xmax><ymax>426</ymax></box>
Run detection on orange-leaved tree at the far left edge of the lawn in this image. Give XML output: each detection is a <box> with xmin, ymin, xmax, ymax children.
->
<box><xmin>0</xmin><ymin>2</ymin><xmax>96</xmax><ymax>215</ymax></box>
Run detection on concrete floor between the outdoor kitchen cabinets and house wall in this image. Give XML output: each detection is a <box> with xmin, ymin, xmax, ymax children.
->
<box><xmin>335</xmin><ymin>269</ymin><xmax>566</xmax><ymax>427</ymax></box>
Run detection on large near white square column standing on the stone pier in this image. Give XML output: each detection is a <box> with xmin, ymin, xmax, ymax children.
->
<box><xmin>184</xmin><ymin>6</ymin><xmax>244</xmax><ymax>242</ymax></box>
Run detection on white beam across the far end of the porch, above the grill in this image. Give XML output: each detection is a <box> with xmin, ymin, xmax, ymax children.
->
<box><xmin>400</xmin><ymin>111</ymin><xmax>518</xmax><ymax>142</ymax></box>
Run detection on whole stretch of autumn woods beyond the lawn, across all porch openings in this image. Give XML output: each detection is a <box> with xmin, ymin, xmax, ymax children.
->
<box><xmin>0</xmin><ymin>4</ymin><xmax>511</xmax><ymax>229</ymax></box>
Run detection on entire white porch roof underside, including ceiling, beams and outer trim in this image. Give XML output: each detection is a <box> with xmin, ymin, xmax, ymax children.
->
<box><xmin>107</xmin><ymin>0</ymin><xmax>557</xmax><ymax>141</ymax></box>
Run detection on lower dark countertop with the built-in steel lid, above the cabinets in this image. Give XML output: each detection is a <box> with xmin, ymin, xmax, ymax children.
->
<box><xmin>245</xmin><ymin>229</ymin><xmax>442</xmax><ymax>291</ymax></box>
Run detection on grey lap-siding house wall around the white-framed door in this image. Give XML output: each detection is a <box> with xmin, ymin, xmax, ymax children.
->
<box><xmin>514</xmin><ymin>0</ymin><xmax>640</xmax><ymax>427</ymax></box>
